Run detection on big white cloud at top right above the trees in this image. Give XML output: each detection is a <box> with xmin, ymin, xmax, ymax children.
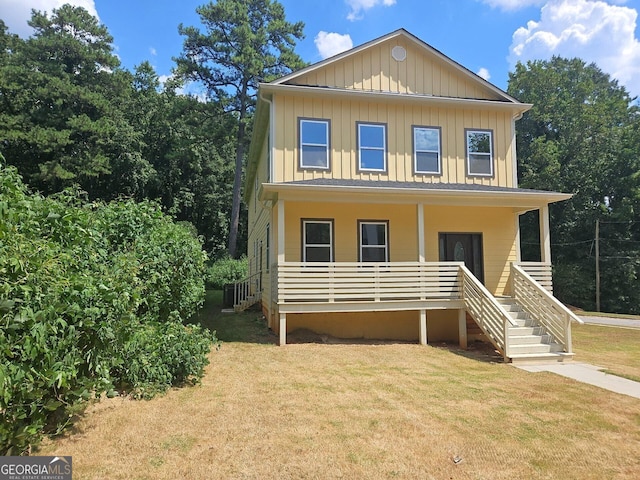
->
<box><xmin>509</xmin><ymin>0</ymin><xmax>640</xmax><ymax>95</ymax></box>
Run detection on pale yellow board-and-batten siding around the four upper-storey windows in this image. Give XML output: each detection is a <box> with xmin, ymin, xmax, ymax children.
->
<box><xmin>273</xmin><ymin>95</ymin><xmax>515</xmax><ymax>187</ymax></box>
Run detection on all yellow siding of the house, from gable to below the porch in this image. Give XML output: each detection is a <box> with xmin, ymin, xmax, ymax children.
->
<box><xmin>245</xmin><ymin>32</ymin><xmax>526</xmax><ymax>340</ymax></box>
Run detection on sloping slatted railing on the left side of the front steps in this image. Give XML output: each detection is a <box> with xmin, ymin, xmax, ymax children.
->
<box><xmin>460</xmin><ymin>265</ymin><xmax>517</xmax><ymax>358</ymax></box>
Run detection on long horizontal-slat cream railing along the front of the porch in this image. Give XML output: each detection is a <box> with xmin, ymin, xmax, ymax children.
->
<box><xmin>277</xmin><ymin>262</ymin><xmax>462</xmax><ymax>311</ymax></box>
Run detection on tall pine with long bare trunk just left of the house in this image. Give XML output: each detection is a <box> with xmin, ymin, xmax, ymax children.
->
<box><xmin>176</xmin><ymin>0</ymin><xmax>304</xmax><ymax>256</ymax></box>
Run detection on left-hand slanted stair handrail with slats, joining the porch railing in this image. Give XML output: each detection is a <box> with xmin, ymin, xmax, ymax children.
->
<box><xmin>460</xmin><ymin>264</ymin><xmax>518</xmax><ymax>359</ymax></box>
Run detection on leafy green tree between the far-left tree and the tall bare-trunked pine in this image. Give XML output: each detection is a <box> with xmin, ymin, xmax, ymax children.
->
<box><xmin>128</xmin><ymin>62</ymin><xmax>236</xmax><ymax>256</ymax></box>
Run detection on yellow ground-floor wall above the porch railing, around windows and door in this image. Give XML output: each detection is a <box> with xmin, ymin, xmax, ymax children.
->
<box><xmin>285</xmin><ymin>199</ymin><xmax>517</xmax><ymax>295</ymax></box>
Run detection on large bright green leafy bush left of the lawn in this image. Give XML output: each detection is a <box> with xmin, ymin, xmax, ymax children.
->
<box><xmin>0</xmin><ymin>164</ymin><xmax>213</xmax><ymax>454</ymax></box>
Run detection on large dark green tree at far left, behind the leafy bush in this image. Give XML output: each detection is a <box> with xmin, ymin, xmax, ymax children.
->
<box><xmin>0</xmin><ymin>5</ymin><xmax>149</xmax><ymax>198</ymax></box>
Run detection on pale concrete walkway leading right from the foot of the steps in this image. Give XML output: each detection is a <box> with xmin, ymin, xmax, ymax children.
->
<box><xmin>514</xmin><ymin>362</ymin><xmax>640</xmax><ymax>399</ymax></box>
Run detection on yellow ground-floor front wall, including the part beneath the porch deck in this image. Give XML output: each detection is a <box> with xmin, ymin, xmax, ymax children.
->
<box><xmin>278</xmin><ymin>201</ymin><xmax>517</xmax><ymax>341</ymax></box>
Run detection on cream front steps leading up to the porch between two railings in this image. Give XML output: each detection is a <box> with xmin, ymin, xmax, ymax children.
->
<box><xmin>496</xmin><ymin>297</ymin><xmax>573</xmax><ymax>363</ymax></box>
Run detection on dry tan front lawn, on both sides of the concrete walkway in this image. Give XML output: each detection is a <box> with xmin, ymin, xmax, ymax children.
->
<box><xmin>37</xmin><ymin>292</ymin><xmax>640</xmax><ymax>480</ymax></box>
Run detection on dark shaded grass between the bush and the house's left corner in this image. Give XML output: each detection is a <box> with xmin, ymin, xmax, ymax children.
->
<box><xmin>191</xmin><ymin>290</ymin><xmax>277</xmax><ymax>344</ymax></box>
